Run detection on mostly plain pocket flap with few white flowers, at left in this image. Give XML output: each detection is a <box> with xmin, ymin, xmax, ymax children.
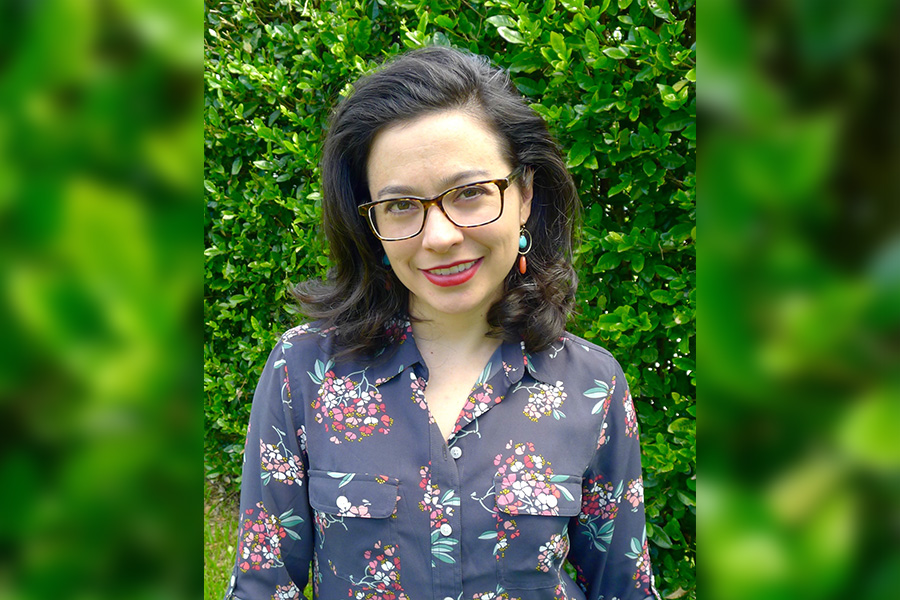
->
<box><xmin>309</xmin><ymin>470</ymin><xmax>400</xmax><ymax>519</ymax></box>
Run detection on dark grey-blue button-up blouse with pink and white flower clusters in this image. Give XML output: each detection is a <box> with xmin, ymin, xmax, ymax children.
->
<box><xmin>226</xmin><ymin>321</ymin><xmax>658</xmax><ymax>600</ymax></box>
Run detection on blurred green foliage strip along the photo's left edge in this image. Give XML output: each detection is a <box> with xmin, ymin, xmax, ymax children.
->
<box><xmin>0</xmin><ymin>0</ymin><xmax>203</xmax><ymax>599</ymax></box>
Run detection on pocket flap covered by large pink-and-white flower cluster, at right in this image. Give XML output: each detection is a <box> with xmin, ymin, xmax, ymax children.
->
<box><xmin>494</xmin><ymin>470</ymin><xmax>581</xmax><ymax>517</ymax></box>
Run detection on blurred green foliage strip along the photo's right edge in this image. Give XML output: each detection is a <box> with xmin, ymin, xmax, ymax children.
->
<box><xmin>698</xmin><ymin>0</ymin><xmax>900</xmax><ymax>600</ymax></box>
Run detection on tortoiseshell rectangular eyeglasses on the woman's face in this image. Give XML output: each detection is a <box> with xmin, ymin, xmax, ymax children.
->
<box><xmin>359</xmin><ymin>168</ymin><xmax>522</xmax><ymax>242</ymax></box>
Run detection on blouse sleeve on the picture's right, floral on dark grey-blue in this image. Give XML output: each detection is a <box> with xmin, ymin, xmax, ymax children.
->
<box><xmin>569</xmin><ymin>363</ymin><xmax>659</xmax><ymax>600</ymax></box>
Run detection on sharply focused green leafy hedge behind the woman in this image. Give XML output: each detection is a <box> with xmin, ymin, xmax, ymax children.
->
<box><xmin>204</xmin><ymin>0</ymin><xmax>696</xmax><ymax>598</ymax></box>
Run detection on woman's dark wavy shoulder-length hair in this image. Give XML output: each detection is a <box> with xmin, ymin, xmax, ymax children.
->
<box><xmin>293</xmin><ymin>47</ymin><xmax>581</xmax><ymax>356</ymax></box>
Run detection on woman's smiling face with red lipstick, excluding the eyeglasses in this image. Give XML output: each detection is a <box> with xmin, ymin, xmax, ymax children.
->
<box><xmin>367</xmin><ymin>110</ymin><xmax>532</xmax><ymax>322</ymax></box>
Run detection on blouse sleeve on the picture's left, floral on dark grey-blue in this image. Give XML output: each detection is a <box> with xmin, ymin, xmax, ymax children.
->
<box><xmin>225</xmin><ymin>342</ymin><xmax>313</xmax><ymax>600</ymax></box>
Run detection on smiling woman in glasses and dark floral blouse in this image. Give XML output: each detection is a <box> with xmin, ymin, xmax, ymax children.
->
<box><xmin>228</xmin><ymin>48</ymin><xmax>656</xmax><ymax>600</ymax></box>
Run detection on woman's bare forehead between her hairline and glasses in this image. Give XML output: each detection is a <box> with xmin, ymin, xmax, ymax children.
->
<box><xmin>366</xmin><ymin>110</ymin><xmax>511</xmax><ymax>193</ymax></box>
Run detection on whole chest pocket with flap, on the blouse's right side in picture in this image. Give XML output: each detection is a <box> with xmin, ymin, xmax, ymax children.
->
<box><xmin>494</xmin><ymin>470</ymin><xmax>581</xmax><ymax>590</ymax></box>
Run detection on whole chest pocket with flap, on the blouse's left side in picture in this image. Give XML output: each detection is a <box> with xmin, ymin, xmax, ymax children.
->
<box><xmin>309</xmin><ymin>470</ymin><xmax>400</xmax><ymax>583</ymax></box>
